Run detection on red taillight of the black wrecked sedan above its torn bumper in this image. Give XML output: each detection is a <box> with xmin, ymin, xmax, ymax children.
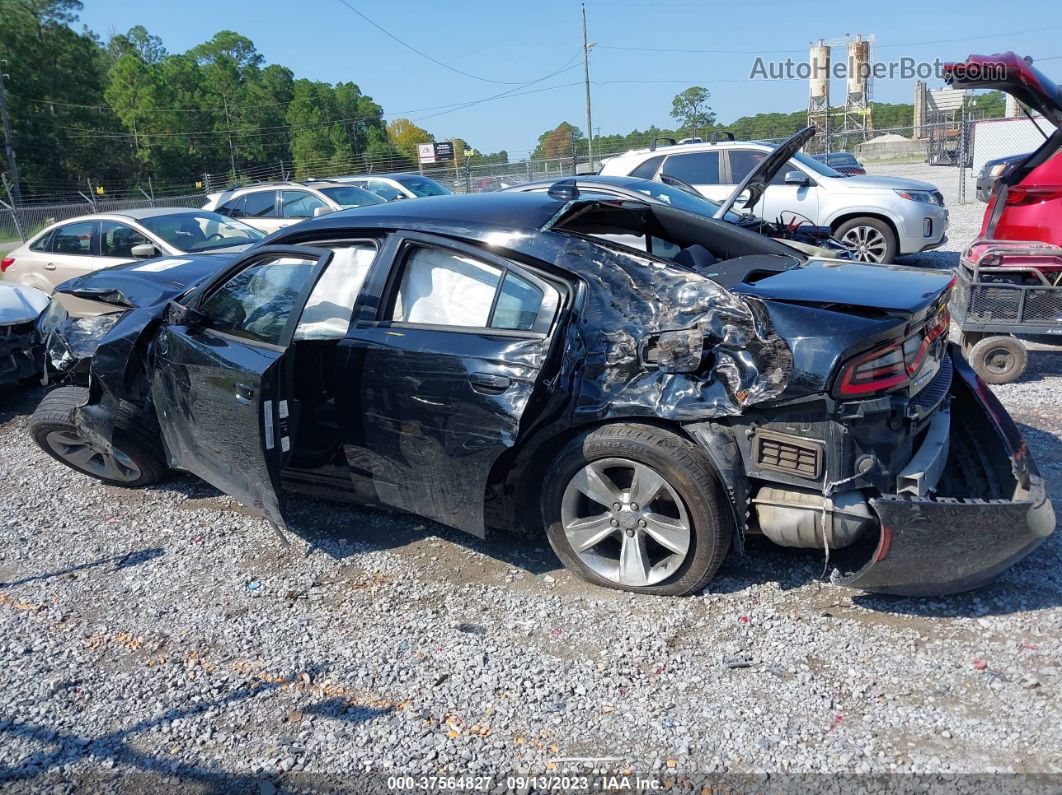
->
<box><xmin>835</xmin><ymin>308</ymin><xmax>950</xmax><ymax>398</ymax></box>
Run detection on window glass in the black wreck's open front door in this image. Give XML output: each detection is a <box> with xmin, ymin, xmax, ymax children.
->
<box><xmin>200</xmin><ymin>257</ymin><xmax>316</xmax><ymax>345</ymax></box>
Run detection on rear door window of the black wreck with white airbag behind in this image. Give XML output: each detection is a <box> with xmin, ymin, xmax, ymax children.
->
<box><xmin>390</xmin><ymin>246</ymin><xmax>559</xmax><ymax>331</ymax></box>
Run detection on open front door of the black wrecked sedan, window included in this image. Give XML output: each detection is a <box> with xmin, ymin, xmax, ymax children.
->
<box><xmin>150</xmin><ymin>246</ymin><xmax>332</xmax><ymax>526</ymax></box>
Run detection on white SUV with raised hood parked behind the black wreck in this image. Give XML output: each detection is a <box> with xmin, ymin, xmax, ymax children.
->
<box><xmin>600</xmin><ymin>134</ymin><xmax>947</xmax><ymax>262</ymax></box>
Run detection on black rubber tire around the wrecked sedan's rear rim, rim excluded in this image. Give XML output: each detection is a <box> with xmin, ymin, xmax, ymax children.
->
<box><xmin>542</xmin><ymin>422</ymin><xmax>733</xmax><ymax>597</ymax></box>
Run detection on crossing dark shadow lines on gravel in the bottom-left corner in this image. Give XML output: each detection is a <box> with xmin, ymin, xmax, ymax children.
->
<box><xmin>0</xmin><ymin>667</ymin><xmax>382</xmax><ymax>793</ymax></box>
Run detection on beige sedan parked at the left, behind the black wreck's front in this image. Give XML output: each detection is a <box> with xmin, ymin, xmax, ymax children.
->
<box><xmin>0</xmin><ymin>207</ymin><xmax>266</xmax><ymax>294</ymax></box>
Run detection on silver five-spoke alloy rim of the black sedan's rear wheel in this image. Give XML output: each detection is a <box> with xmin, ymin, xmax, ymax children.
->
<box><xmin>561</xmin><ymin>459</ymin><xmax>692</xmax><ymax>586</ymax></box>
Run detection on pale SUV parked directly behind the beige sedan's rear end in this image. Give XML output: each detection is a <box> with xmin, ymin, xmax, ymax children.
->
<box><xmin>203</xmin><ymin>179</ymin><xmax>384</xmax><ymax>234</ymax></box>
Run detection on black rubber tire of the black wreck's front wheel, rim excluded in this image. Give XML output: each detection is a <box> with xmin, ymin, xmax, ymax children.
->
<box><xmin>30</xmin><ymin>386</ymin><xmax>169</xmax><ymax>488</ymax></box>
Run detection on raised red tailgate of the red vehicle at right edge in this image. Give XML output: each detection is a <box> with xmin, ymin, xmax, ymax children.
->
<box><xmin>944</xmin><ymin>52</ymin><xmax>1062</xmax><ymax>127</ymax></box>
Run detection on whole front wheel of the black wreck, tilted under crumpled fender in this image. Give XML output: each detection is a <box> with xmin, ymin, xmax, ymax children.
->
<box><xmin>30</xmin><ymin>386</ymin><xmax>167</xmax><ymax>488</ymax></box>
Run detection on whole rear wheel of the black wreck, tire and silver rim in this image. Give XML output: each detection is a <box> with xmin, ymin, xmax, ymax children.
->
<box><xmin>543</xmin><ymin>424</ymin><xmax>733</xmax><ymax>595</ymax></box>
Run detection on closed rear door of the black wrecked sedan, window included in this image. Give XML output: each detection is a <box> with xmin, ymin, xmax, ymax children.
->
<box><xmin>342</xmin><ymin>234</ymin><xmax>566</xmax><ymax>536</ymax></box>
